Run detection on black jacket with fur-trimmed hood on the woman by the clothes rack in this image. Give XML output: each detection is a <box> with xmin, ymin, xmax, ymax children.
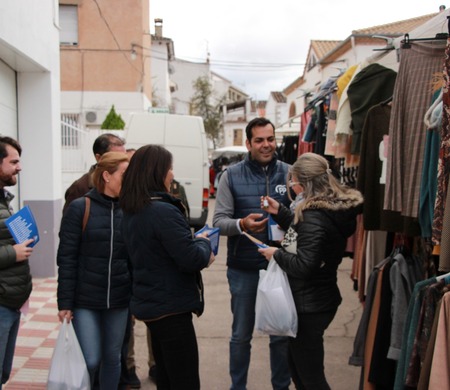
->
<box><xmin>274</xmin><ymin>190</ymin><xmax>363</xmax><ymax>313</ymax></box>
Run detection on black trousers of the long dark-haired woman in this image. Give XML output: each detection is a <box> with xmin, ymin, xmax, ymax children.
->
<box><xmin>146</xmin><ymin>313</ymin><xmax>200</xmax><ymax>390</ymax></box>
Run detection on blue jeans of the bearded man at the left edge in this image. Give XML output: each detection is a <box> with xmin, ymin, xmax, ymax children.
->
<box><xmin>0</xmin><ymin>305</ymin><xmax>20</xmax><ymax>390</ymax></box>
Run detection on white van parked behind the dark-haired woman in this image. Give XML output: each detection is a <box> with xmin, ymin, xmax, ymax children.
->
<box><xmin>125</xmin><ymin>113</ymin><xmax>209</xmax><ymax>229</ymax></box>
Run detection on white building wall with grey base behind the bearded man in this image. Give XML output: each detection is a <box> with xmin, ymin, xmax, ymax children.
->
<box><xmin>0</xmin><ymin>0</ymin><xmax>62</xmax><ymax>276</ymax></box>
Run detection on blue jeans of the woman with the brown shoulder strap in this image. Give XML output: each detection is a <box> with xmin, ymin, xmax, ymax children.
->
<box><xmin>72</xmin><ymin>308</ymin><xmax>128</xmax><ymax>390</ymax></box>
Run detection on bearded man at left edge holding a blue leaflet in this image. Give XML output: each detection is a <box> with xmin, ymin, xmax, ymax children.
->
<box><xmin>0</xmin><ymin>137</ymin><xmax>33</xmax><ymax>390</ymax></box>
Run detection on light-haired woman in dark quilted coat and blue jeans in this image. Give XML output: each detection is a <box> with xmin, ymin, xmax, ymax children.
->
<box><xmin>57</xmin><ymin>152</ymin><xmax>131</xmax><ymax>390</ymax></box>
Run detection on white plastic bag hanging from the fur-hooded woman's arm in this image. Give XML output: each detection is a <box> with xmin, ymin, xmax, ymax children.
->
<box><xmin>255</xmin><ymin>258</ymin><xmax>298</xmax><ymax>337</ymax></box>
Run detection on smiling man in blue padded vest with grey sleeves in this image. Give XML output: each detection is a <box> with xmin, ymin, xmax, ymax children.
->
<box><xmin>213</xmin><ymin>118</ymin><xmax>290</xmax><ymax>390</ymax></box>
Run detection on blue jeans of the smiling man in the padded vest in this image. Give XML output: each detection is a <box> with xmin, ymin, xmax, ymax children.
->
<box><xmin>227</xmin><ymin>268</ymin><xmax>291</xmax><ymax>390</ymax></box>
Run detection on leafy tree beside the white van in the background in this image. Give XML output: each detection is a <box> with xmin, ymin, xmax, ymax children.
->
<box><xmin>191</xmin><ymin>77</ymin><xmax>224</xmax><ymax>148</ymax></box>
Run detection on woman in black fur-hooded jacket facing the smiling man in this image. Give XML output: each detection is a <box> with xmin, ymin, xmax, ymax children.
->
<box><xmin>259</xmin><ymin>153</ymin><xmax>363</xmax><ymax>390</ymax></box>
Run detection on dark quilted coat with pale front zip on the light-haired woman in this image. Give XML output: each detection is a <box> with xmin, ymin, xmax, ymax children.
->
<box><xmin>57</xmin><ymin>188</ymin><xmax>131</xmax><ymax>310</ymax></box>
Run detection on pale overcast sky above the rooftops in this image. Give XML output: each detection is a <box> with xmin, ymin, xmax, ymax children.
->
<box><xmin>150</xmin><ymin>0</ymin><xmax>450</xmax><ymax>100</ymax></box>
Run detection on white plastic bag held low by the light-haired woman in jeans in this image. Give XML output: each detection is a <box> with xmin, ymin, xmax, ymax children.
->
<box><xmin>47</xmin><ymin>319</ymin><xmax>91</xmax><ymax>390</ymax></box>
